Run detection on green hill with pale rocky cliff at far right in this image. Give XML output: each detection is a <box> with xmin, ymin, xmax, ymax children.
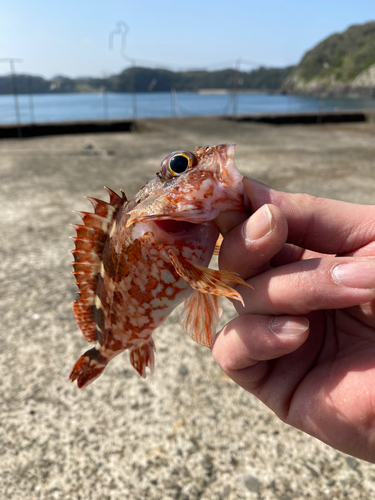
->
<box><xmin>283</xmin><ymin>22</ymin><xmax>375</xmax><ymax>96</ymax></box>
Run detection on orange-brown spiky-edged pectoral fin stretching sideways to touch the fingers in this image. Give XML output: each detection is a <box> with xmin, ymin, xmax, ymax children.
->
<box><xmin>168</xmin><ymin>249</ymin><xmax>251</xmax><ymax>305</ymax></box>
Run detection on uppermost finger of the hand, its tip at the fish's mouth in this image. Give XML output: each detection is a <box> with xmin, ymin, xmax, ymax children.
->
<box><xmin>243</xmin><ymin>177</ymin><xmax>375</xmax><ymax>254</ymax></box>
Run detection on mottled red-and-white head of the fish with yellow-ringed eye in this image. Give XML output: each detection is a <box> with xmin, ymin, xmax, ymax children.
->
<box><xmin>126</xmin><ymin>144</ymin><xmax>249</xmax><ymax>227</ymax></box>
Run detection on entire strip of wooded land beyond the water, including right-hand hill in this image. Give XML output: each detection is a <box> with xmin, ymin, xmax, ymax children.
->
<box><xmin>0</xmin><ymin>22</ymin><xmax>375</xmax><ymax>98</ymax></box>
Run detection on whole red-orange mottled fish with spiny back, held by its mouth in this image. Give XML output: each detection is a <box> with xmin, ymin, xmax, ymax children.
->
<box><xmin>69</xmin><ymin>144</ymin><xmax>249</xmax><ymax>388</ymax></box>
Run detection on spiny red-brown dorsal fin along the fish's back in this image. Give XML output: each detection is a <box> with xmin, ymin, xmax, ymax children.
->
<box><xmin>71</xmin><ymin>188</ymin><xmax>127</xmax><ymax>342</ymax></box>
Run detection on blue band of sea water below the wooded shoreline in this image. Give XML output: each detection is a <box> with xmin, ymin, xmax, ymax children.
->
<box><xmin>0</xmin><ymin>92</ymin><xmax>375</xmax><ymax>124</ymax></box>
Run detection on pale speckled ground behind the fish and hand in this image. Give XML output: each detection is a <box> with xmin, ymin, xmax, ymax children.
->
<box><xmin>0</xmin><ymin>115</ymin><xmax>375</xmax><ymax>500</ymax></box>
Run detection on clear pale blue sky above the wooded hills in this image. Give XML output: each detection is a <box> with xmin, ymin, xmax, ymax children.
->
<box><xmin>0</xmin><ymin>0</ymin><xmax>375</xmax><ymax>77</ymax></box>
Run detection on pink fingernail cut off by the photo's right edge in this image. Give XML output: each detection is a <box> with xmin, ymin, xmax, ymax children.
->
<box><xmin>332</xmin><ymin>260</ymin><xmax>375</xmax><ymax>289</ymax></box>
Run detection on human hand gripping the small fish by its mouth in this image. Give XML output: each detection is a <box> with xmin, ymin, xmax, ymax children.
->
<box><xmin>212</xmin><ymin>179</ymin><xmax>375</xmax><ymax>462</ymax></box>
